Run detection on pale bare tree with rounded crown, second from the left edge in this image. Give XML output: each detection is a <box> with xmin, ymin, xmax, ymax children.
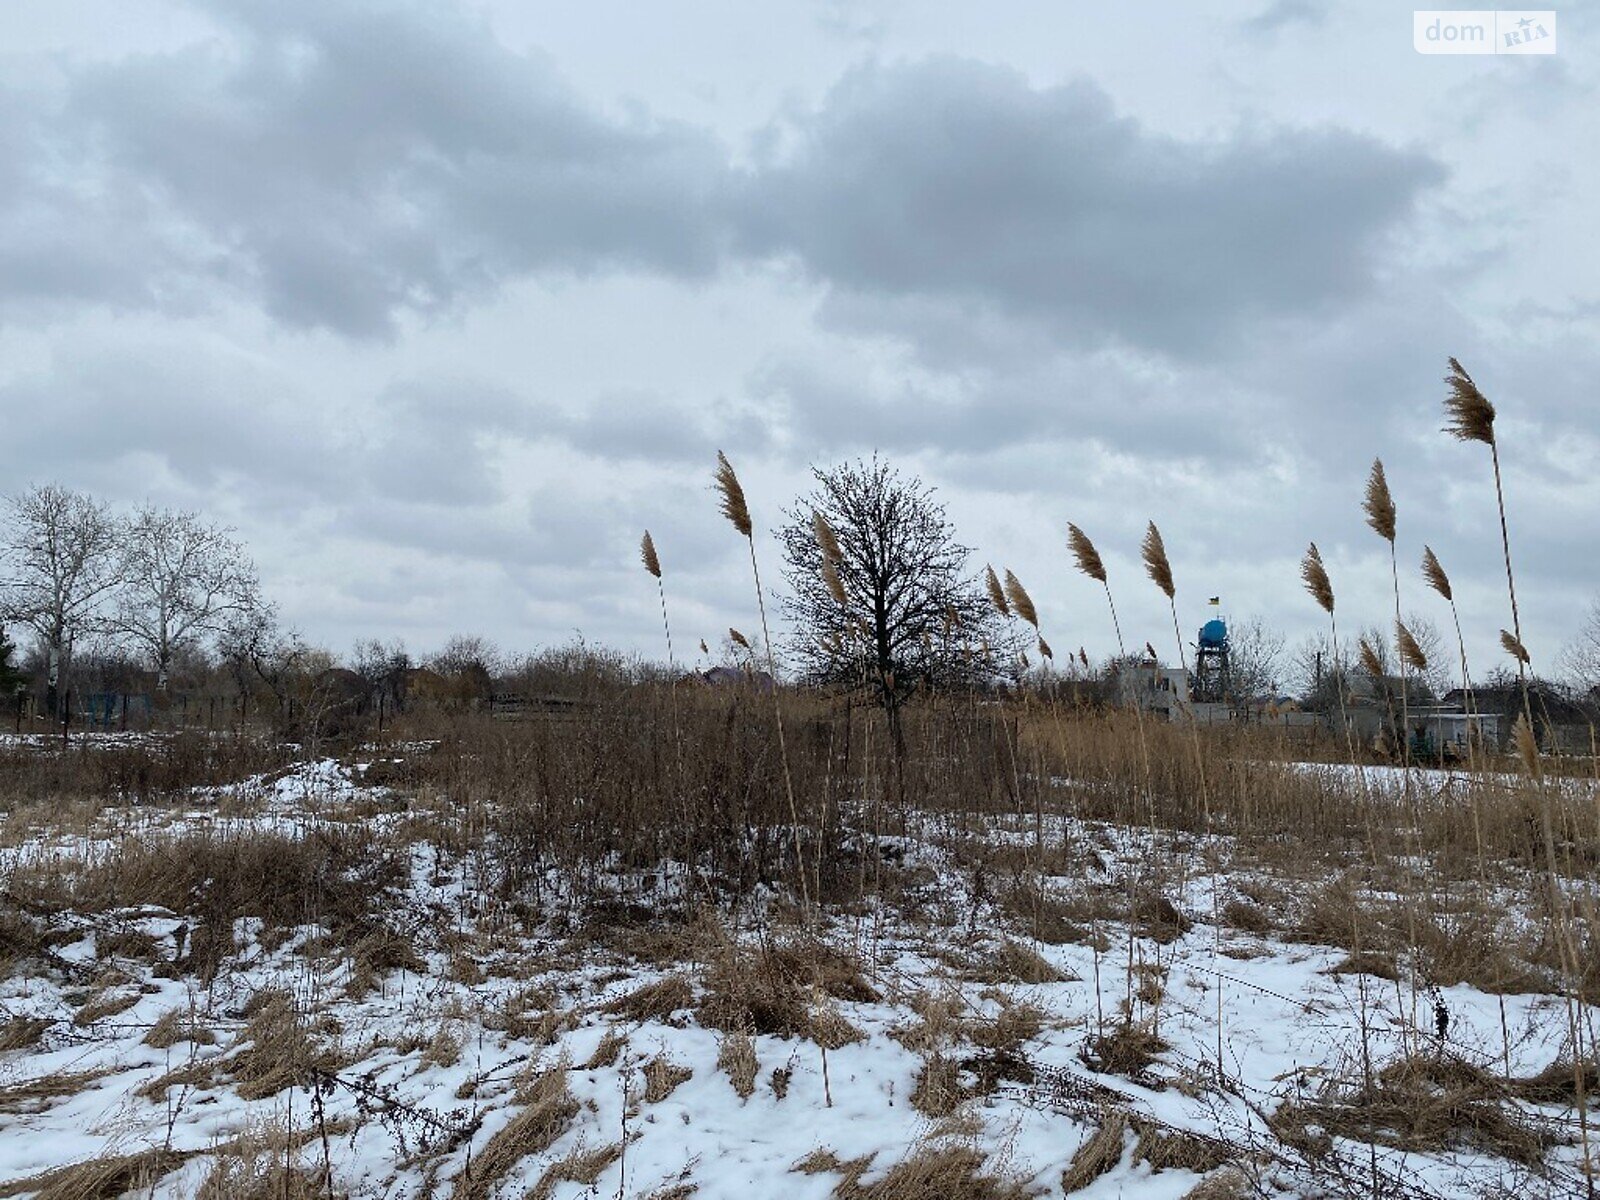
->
<box><xmin>112</xmin><ymin>506</ymin><xmax>261</xmax><ymax>693</ymax></box>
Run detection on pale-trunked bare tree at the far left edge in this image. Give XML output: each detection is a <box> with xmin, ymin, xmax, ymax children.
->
<box><xmin>0</xmin><ymin>483</ymin><xmax>122</xmax><ymax>715</ymax></box>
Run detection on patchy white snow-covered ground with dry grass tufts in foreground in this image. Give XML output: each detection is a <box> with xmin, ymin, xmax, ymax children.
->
<box><xmin>0</xmin><ymin>760</ymin><xmax>1594</xmax><ymax>1200</ymax></box>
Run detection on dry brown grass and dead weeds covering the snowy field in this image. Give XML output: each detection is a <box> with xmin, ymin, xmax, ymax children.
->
<box><xmin>0</xmin><ymin>640</ymin><xmax>1600</xmax><ymax>1198</ymax></box>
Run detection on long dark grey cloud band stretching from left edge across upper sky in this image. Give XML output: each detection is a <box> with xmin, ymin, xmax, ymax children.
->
<box><xmin>0</xmin><ymin>17</ymin><xmax>1443</xmax><ymax>358</ymax></box>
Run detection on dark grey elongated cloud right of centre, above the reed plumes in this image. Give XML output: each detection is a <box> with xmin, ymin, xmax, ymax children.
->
<box><xmin>744</xmin><ymin>59</ymin><xmax>1445</xmax><ymax>358</ymax></box>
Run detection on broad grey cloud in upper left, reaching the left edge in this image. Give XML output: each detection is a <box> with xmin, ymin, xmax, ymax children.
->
<box><xmin>0</xmin><ymin>0</ymin><xmax>726</xmax><ymax>336</ymax></box>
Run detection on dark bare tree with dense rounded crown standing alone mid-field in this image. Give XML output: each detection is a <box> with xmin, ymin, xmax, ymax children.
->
<box><xmin>778</xmin><ymin>458</ymin><xmax>1016</xmax><ymax>738</ymax></box>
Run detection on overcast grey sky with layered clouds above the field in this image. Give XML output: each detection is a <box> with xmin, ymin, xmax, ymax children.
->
<box><xmin>0</xmin><ymin>0</ymin><xmax>1600</xmax><ymax>681</ymax></box>
